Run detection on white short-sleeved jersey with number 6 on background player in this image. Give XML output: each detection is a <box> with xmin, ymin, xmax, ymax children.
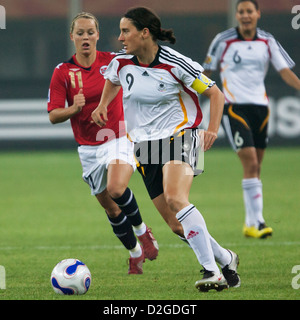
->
<box><xmin>203</xmin><ymin>28</ymin><xmax>295</xmax><ymax>105</ymax></box>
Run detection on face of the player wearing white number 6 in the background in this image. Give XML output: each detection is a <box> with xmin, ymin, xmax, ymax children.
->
<box><xmin>236</xmin><ymin>1</ymin><xmax>260</xmax><ymax>34</ymax></box>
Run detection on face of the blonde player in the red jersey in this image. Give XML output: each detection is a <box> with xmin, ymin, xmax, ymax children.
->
<box><xmin>70</xmin><ymin>18</ymin><xmax>99</xmax><ymax>56</ymax></box>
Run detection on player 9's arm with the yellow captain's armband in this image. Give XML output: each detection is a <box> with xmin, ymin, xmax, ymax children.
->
<box><xmin>192</xmin><ymin>74</ymin><xmax>225</xmax><ymax>151</ymax></box>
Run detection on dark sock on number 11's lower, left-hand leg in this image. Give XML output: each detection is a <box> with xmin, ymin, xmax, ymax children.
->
<box><xmin>107</xmin><ymin>212</ymin><xmax>137</xmax><ymax>250</ymax></box>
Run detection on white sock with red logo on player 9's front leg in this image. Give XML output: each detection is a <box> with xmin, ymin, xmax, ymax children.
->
<box><xmin>176</xmin><ymin>204</ymin><xmax>220</xmax><ymax>274</ymax></box>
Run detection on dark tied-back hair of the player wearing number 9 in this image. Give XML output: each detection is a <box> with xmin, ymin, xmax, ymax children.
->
<box><xmin>124</xmin><ymin>7</ymin><xmax>176</xmax><ymax>44</ymax></box>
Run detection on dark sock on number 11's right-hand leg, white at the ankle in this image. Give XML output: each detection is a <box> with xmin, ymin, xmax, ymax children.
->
<box><xmin>113</xmin><ymin>188</ymin><xmax>146</xmax><ymax>236</ymax></box>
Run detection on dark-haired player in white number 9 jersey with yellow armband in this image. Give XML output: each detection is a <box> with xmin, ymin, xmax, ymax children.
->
<box><xmin>92</xmin><ymin>7</ymin><xmax>240</xmax><ymax>291</ymax></box>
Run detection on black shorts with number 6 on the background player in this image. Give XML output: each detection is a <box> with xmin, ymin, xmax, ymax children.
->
<box><xmin>222</xmin><ymin>104</ymin><xmax>270</xmax><ymax>151</ymax></box>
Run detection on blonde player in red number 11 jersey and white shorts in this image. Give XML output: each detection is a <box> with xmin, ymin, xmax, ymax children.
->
<box><xmin>48</xmin><ymin>12</ymin><xmax>158</xmax><ymax>274</ymax></box>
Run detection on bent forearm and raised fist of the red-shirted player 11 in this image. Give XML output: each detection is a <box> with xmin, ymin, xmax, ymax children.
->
<box><xmin>49</xmin><ymin>89</ymin><xmax>85</xmax><ymax>124</ymax></box>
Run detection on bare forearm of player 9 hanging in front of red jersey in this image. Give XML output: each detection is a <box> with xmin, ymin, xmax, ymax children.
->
<box><xmin>92</xmin><ymin>80</ymin><xmax>121</xmax><ymax>127</ymax></box>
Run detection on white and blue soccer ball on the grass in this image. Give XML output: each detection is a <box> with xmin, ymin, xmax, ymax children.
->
<box><xmin>50</xmin><ymin>259</ymin><xmax>92</xmax><ymax>295</ymax></box>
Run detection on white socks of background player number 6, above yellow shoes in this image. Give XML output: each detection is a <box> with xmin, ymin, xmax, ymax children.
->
<box><xmin>242</xmin><ymin>178</ymin><xmax>265</xmax><ymax>228</ymax></box>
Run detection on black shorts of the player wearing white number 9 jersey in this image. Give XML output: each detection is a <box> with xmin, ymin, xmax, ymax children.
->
<box><xmin>134</xmin><ymin>129</ymin><xmax>204</xmax><ymax>199</ymax></box>
